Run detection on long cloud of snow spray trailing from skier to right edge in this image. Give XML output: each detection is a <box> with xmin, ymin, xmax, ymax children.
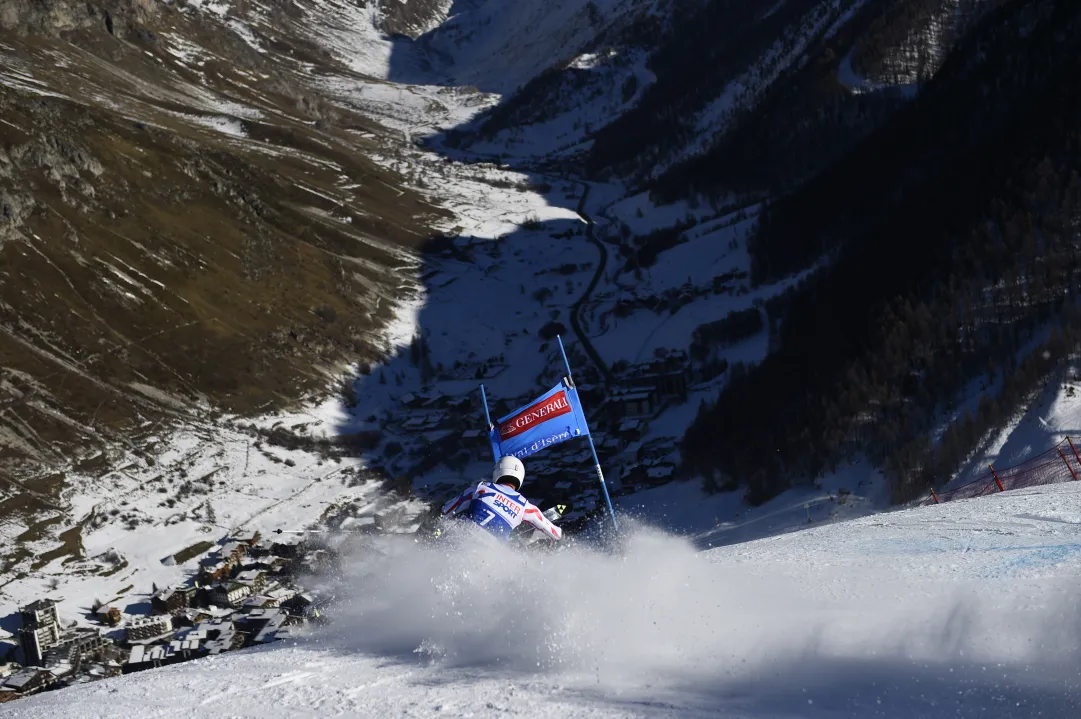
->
<box><xmin>316</xmin><ymin>528</ymin><xmax>1081</xmax><ymax>704</ymax></box>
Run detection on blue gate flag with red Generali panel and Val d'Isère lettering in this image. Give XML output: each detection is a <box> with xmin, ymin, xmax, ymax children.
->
<box><xmin>489</xmin><ymin>378</ymin><xmax>589</xmax><ymax>460</ymax></box>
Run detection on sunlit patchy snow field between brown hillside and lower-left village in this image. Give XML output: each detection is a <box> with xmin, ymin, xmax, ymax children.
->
<box><xmin>0</xmin><ymin>415</ymin><xmax>419</xmax><ymax>638</ymax></box>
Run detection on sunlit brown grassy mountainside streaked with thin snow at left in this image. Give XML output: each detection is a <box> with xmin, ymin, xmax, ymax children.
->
<box><xmin>0</xmin><ymin>15</ymin><xmax>443</xmax><ymax>480</ymax></box>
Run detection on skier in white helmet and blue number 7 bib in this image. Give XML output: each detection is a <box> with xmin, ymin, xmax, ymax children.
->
<box><xmin>442</xmin><ymin>456</ymin><xmax>563</xmax><ymax>540</ymax></box>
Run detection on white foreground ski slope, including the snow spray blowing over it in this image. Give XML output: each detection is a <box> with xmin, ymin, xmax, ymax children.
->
<box><xmin>14</xmin><ymin>484</ymin><xmax>1081</xmax><ymax>719</ymax></box>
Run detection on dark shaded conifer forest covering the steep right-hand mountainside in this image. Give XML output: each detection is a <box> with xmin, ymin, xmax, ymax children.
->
<box><xmin>666</xmin><ymin>0</ymin><xmax>1081</xmax><ymax>502</ymax></box>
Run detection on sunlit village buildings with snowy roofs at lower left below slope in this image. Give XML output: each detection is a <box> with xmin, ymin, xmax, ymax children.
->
<box><xmin>0</xmin><ymin>532</ymin><xmax>336</xmax><ymax>703</ymax></box>
